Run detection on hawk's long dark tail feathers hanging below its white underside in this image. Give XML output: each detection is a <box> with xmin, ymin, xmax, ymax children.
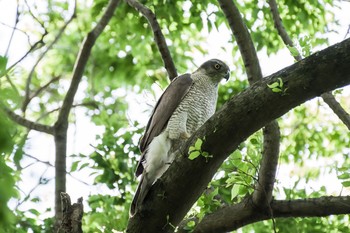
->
<box><xmin>129</xmin><ymin>173</ymin><xmax>153</xmax><ymax>217</ymax></box>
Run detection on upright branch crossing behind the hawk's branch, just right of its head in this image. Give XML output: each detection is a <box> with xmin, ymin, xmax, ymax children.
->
<box><xmin>218</xmin><ymin>0</ymin><xmax>280</xmax><ymax>209</ymax></box>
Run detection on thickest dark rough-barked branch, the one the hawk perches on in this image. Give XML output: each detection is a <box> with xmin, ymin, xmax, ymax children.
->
<box><xmin>127</xmin><ymin>39</ymin><xmax>350</xmax><ymax>232</ymax></box>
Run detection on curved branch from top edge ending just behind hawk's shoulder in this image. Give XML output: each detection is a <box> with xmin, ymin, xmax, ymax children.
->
<box><xmin>126</xmin><ymin>0</ymin><xmax>177</xmax><ymax>80</ymax></box>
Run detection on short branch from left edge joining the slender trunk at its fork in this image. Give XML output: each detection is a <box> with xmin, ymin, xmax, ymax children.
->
<box><xmin>2</xmin><ymin>106</ymin><xmax>54</xmax><ymax>135</ymax></box>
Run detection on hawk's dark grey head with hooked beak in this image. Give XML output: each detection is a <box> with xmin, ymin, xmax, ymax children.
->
<box><xmin>197</xmin><ymin>59</ymin><xmax>230</xmax><ymax>83</ymax></box>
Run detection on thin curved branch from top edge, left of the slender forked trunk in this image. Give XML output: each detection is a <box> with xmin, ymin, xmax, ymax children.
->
<box><xmin>22</xmin><ymin>0</ymin><xmax>77</xmax><ymax>113</ymax></box>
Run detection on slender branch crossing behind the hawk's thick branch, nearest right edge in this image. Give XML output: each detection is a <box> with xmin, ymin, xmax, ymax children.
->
<box><xmin>269</xmin><ymin>0</ymin><xmax>350</xmax><ymax>130</ymax></box>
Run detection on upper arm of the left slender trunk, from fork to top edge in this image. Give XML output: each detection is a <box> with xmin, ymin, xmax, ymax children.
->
<box><xmin>56</xmin><ymin>0</ymin><xmax>120</xmax><ymax>125</ymax></box>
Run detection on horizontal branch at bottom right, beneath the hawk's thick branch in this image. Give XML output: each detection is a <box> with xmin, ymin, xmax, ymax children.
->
<box><xmin>193</xmin><ymin>196</ymin><xmax>350</xmax><ymax>233</ymax></box>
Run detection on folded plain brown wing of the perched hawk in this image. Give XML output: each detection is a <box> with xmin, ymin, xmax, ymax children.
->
<box><xmin>135</xmin><ymin>74</ymin><xmax>193</xmax><ymax>176</ymax></box>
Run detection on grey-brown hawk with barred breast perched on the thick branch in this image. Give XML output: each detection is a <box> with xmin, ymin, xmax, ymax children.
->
<box><xmin>130</xmin><ymin>59</ymin><xmax>230</xmax><ymax>216</ymax></box>
